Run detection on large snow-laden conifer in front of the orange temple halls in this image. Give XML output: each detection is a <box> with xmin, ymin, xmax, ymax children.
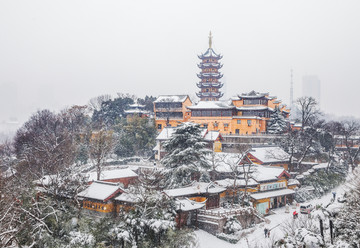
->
<box><xmin>162</xmin><ymin>122</ymin><xmax>210</xmax><ymax>188</ymax></box>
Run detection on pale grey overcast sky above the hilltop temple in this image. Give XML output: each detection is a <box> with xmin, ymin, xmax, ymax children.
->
<box><xmin>0</xmin><ymin>0</ymin><xmax>360</xmax><ymax>124</ymax></box>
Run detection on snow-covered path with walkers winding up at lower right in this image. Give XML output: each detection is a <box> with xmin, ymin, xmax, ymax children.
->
<box><xmin>195</xmin><ymin>186</ymin><xmax>344</xmax><ymax>248</ymax></box>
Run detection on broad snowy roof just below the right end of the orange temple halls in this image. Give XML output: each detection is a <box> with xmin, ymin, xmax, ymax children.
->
<box><xmin>249</xmin><ymin>146</ymin><xmax>290</xmax><ymax>163</ymax></box>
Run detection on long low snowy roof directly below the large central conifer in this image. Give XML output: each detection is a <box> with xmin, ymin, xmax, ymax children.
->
<box><xmin>164</xmin><ymin>182</ymin><xmax>226</xmax><ymax>197</ymax></box>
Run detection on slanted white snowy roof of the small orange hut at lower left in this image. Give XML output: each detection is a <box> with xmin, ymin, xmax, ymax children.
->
<box><xmin>78</xmin><ymin>181</ymin><xmax>124</xmax><ymax>201</ymax></box>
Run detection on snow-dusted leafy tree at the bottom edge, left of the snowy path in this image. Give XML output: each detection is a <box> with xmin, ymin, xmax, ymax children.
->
<box><xmin>109</xmin><ymin>185</ymin><xmax>194</xmax><ymax>247</ymax></box>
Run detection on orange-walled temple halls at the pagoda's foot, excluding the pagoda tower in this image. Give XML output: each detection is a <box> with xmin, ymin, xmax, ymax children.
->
<box><xmin>154</xmin><ymin>91</ymin><xmax>290</xmax><ymax>135</ymax></box>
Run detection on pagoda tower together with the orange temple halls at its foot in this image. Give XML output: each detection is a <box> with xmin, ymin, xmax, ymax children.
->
<box><xmin>154</xmin><ymin>32</ymin><xmax>290</xmax><ymax>135</ymax></box>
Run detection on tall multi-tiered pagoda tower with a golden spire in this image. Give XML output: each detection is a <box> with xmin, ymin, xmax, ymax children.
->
<box><xmin>196</xmin><ymin>32</ymin><xmax>223</xmax><ymax>101</ymax></box>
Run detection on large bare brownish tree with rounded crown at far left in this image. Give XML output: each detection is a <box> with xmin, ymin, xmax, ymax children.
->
<box><xmin>14</xmin><ymin>106</ymin><xmax>87</xmax><ymax>179</ymax></box>
